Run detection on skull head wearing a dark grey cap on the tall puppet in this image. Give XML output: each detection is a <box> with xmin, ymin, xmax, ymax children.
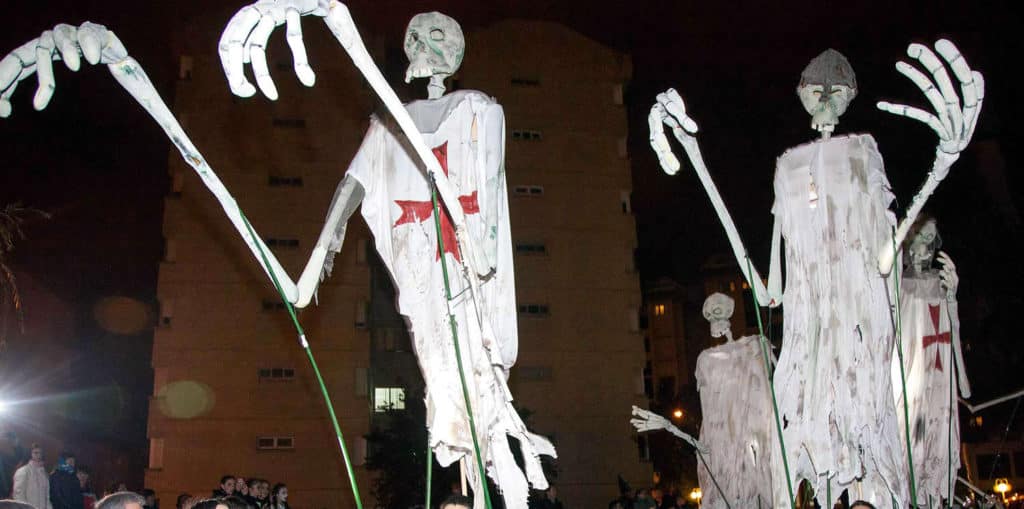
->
<box><xmin>797</xmin><ymin>49</ymin><xmax>857</xmax><ymax>137</ymax></box>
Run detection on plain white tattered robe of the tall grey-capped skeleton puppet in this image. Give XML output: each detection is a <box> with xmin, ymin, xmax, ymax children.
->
<box><xmin>772</xmin><ymin>135</ymin><xmax>908</xmax><ymax>507</ymax></box>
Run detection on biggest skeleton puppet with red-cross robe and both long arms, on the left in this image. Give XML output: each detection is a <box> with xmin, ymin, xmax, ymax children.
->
<box><xmin>0</xmin><ymin>0</ymin><xmax>555</xmax><ymax>508</ymax></box>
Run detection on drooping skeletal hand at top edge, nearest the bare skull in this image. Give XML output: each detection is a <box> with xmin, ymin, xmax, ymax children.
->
<box><xmin>217</xmin><ymin>0</ymin><xmax>344</xmax><ymax>100</ymax></box>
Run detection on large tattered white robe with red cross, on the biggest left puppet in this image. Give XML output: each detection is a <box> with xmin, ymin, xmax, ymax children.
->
<box><xmin>348</xmin><ymin>90</ymin><xmax>555</xmax><ymax>509</ymax></box>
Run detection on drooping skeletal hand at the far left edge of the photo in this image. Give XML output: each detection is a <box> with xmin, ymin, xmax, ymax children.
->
<box><xmin>0</xmin><ymin>22</ymin><xmax>128</xmax><ymax>118</ymax></box>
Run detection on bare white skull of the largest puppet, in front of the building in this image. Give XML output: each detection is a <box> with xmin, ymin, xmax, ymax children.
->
<box><xmin>406</xmin><ymin>12</ymin><xmax>466</xmax><ymax>83</ymax></box>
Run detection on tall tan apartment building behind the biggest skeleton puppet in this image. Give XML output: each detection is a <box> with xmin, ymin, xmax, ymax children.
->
<box><xmin>146</xmin><ymin>12</ymin><xmax>650</xmax><ymax>509</ymax></box>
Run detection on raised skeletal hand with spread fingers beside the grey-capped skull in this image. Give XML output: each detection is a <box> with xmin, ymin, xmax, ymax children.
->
<box><xmin>878</xmin><ymin>39</ymin><xmax>985</xmax><ymax>174</ymax></box>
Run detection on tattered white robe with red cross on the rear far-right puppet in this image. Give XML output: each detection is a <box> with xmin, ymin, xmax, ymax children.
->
<box><xmin>892</xmin><ymin>273</ymin><xmax>959</xmax><ymax>504</ymax></box>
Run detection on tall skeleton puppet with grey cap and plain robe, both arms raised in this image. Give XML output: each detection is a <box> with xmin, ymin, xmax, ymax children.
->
<box><xmin>649</xmin><ymin>40</ymin><xmax>984</xmax><ymax>507</ymax></box>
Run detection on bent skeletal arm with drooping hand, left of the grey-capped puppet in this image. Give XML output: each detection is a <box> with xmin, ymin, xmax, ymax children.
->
<box><xmin>647</xmin><ymin>88</ymin><xmax>782</xmax><ymax>307</ymax></box>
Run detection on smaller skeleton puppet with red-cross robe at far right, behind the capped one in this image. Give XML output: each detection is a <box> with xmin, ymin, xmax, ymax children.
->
<box><xmin>892</xmin><ymin>215</ymin><xmax>971</xmax><ymax>502</ymax></box>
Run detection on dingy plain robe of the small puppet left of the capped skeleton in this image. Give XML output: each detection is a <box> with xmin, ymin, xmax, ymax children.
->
<box><xmin>696</xmin><ymin>336</ymin><xmax>778</xmax><ymax>509</ymax></box>
